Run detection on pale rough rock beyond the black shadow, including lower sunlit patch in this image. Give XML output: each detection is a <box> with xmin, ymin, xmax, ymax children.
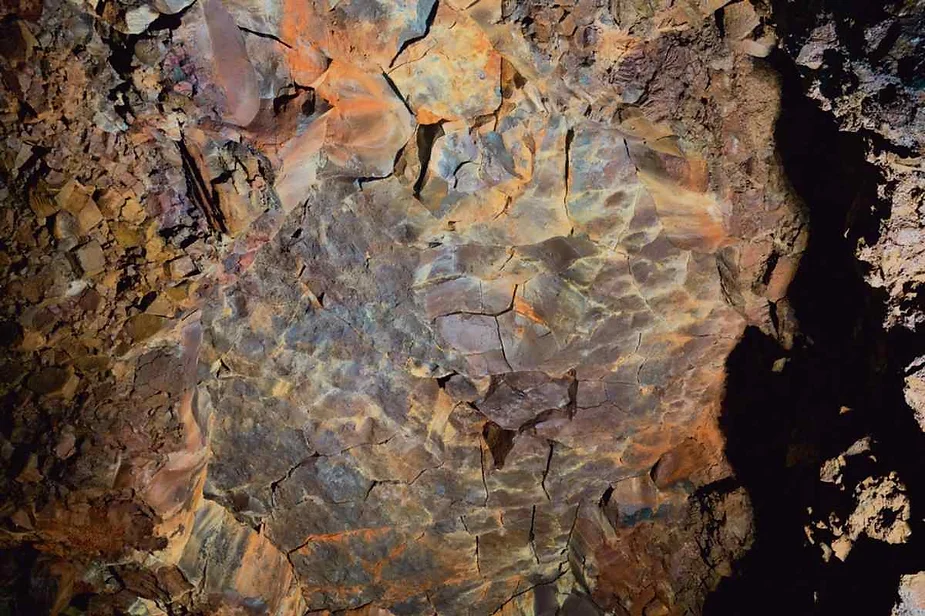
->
<box><xmin>774</xmin><ymin>1</ymin><xmax>925</xmax><ymax>614</ymax></box>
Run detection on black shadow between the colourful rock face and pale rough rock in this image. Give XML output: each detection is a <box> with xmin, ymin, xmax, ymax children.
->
<box><xmin>704</xmin><ymin>47</ymin><xmax>925</xmax><ymax>616</ymax></box>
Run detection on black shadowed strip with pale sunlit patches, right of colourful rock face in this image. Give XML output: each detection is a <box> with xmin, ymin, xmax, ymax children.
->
<box><xmin>708</xmin><ymin>0</ymin><xmax>925</xmax><ymax>614</ymax></box>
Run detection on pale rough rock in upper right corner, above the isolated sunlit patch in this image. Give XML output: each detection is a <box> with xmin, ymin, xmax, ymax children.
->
<box><xmin>780</xmin><ymin>2</ymin><xmax>925</xmax><ymax>342</ymax></box>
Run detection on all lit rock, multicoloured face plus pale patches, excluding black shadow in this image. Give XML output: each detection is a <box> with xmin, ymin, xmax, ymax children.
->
<box><xmin>0</xmin><ymin>0</ymin><xmax>925</xmax><ymax>616</ymax></box>
